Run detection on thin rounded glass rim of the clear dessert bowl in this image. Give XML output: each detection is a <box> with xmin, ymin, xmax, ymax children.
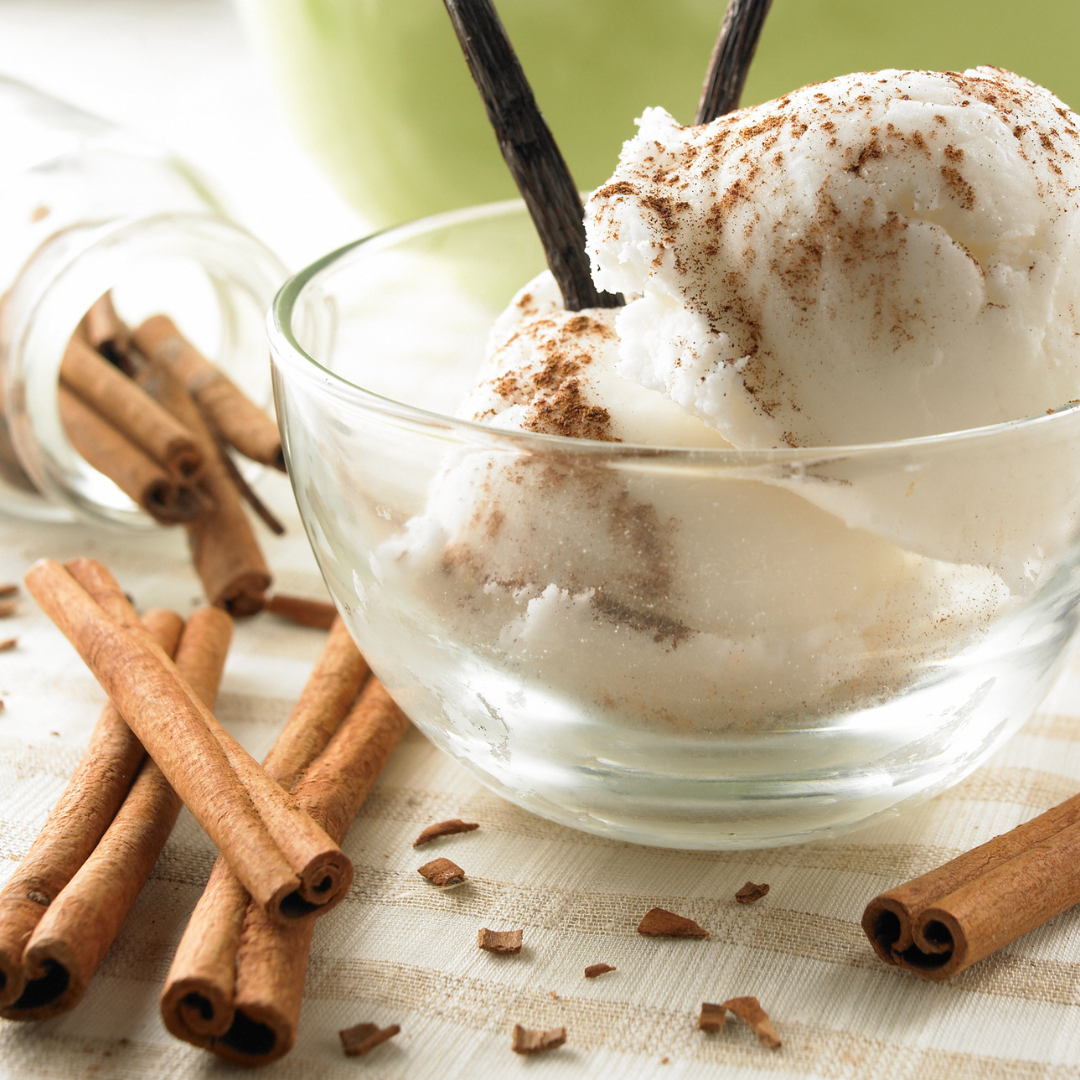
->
<box><xmin>267</xmin><ymin>199</ymin><xmax>1080</xmax><ymax>465</ymax></box>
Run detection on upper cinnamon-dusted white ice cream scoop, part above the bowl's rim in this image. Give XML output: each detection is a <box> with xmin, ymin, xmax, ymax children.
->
<box><xmin>586</xmin><ymin>68</ymin><xmax>1080</xmax><ymax>448</ymax></box>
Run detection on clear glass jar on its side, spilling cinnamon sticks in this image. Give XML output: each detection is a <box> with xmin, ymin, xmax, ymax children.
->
<box><xmin>0</xmin><ymin>79</ymin><xmax>285</xmax><ymax>528</ymax></box>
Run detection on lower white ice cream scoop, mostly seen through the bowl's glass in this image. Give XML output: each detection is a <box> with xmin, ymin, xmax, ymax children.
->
<box><xmin>373</xmin><ymin>267</ymin><xmax>1008</xmax><ymax>732</ymax></box>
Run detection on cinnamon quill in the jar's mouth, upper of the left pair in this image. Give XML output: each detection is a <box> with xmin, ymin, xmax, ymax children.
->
<box><xmin>60</xmin><ymin>335</ymin><xmax>203</xmax><ymax>482</ymax></box>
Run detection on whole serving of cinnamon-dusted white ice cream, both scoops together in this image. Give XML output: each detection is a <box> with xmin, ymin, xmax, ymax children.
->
<box><xmin>373</xmin><ymin>69</ymin><xmax>1080</xmax><ymax>733</ymax></box>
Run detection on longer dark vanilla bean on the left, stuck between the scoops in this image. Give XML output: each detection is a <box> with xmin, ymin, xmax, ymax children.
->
<box><xmin>444</xmin><ymin>0</ymin><xmax>622</xmax><ymax>311</ymax></box>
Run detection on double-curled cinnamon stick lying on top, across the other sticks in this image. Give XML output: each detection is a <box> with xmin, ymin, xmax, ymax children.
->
<box><xmin>26</xmin><ymin>559</ymin><xmax>352</xmax><ymax>917</ymax></box>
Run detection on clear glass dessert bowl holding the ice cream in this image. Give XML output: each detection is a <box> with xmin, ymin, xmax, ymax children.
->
<box><xmin>270</xmin><ymin>203</ymin><xmax>1080</xmax><ymax>849</ymax></box>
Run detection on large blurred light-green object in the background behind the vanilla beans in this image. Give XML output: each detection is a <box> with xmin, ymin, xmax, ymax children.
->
<box><xmin>239</xmin><ymin>0</ymin><xmax>1080</xmax><ymax>225</ymax></box>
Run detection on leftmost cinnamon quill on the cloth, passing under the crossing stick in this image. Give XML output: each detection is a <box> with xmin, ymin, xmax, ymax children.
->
<box><xmin>0</xmin><ymin>609</ymin><xmax>184</xmax><ymax>1014</ymax></box>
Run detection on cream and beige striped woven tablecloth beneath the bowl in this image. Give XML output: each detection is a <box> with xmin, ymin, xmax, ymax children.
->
<box><xmin>0</xmin><ymin>478</ymin><xmax>1080</xmax><ymax>1080</ymax></box>
